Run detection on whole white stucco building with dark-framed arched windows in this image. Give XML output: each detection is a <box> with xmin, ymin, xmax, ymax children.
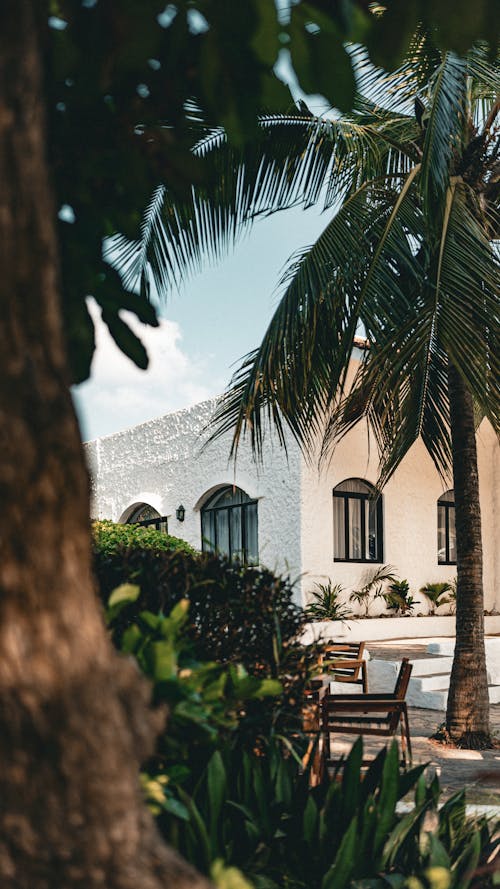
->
<box><xmin>85</xmin><ymin>354</ymin><xmax>500</xmax><ymax>612</ymax></box>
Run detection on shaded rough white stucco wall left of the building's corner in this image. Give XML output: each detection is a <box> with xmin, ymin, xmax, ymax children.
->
<box><xmin>85</xmin><ymin>400</ymin><xmax>301</xmax><ymax>598</ymax></box>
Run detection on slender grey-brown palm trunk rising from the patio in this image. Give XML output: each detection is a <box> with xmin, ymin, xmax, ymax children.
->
<box><xmin>446</xmin><ymin>362</ymin><xmax>490</xmax><ymax>748</ymax></box>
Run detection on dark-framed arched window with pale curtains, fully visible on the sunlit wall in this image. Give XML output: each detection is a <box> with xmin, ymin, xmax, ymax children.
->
<box><xmin>333</xmin><ymin>478</ymin><xmax>383</xmax><ymax>562</ymax></box>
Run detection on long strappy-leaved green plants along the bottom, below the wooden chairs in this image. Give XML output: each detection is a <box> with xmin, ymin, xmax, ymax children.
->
<box><xmin>158</xmin><ymin>738</ymin><xmax>498</xmax><ymax>889</ymax></box>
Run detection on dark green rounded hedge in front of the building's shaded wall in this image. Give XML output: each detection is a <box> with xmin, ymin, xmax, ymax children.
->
<box><xmin>95</xmin><ymin>538</ymin><xmax>304</xmax><ymax>675</ymax></box>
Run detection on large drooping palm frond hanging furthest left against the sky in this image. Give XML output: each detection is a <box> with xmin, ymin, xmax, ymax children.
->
<box><xmin>207</xmin><ymin>168</ymin><xmax>418</xmax><ymax>462</ymax></box>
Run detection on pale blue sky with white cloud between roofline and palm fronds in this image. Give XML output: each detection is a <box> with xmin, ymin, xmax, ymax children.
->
<box><xmin>74</xmin><ymin>201</ymin><xmax>328</xmax><ymax>440</ymax></box>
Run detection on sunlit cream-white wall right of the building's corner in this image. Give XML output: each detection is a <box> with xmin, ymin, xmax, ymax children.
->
<box><xmin>301</xmin><ymin>414</ymin><xmax>500</xmax><ymax>614</ymax></box>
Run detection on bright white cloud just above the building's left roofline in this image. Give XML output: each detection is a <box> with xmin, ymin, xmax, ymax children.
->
<box><xmin>73</xmin><ymin>300</ymin><xmax>224</xmax><ymax>439</ymax></box>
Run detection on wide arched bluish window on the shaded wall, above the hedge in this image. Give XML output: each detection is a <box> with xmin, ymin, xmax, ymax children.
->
<box><xmin>201</xmin><ymin>485</ymin><xmax>259</xmax><ymax>565</ymax></box>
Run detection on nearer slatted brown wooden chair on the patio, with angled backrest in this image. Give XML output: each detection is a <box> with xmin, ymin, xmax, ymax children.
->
<box><xmin>321</xmin><ymin>657</ymin><xmax>412</xmax><ymax>767</ymax></box>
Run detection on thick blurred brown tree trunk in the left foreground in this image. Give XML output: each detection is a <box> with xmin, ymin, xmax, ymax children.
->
<box><xmin>0</xmin><ymin>0</ymin><xmax>207</xmax><ymax>889</ymax></box>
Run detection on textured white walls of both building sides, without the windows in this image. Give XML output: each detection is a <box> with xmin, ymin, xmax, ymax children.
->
<box><xmin>86</xmin><ymin>386</ymin><xmax>500</xmax><ymax>613</ymax></box>
